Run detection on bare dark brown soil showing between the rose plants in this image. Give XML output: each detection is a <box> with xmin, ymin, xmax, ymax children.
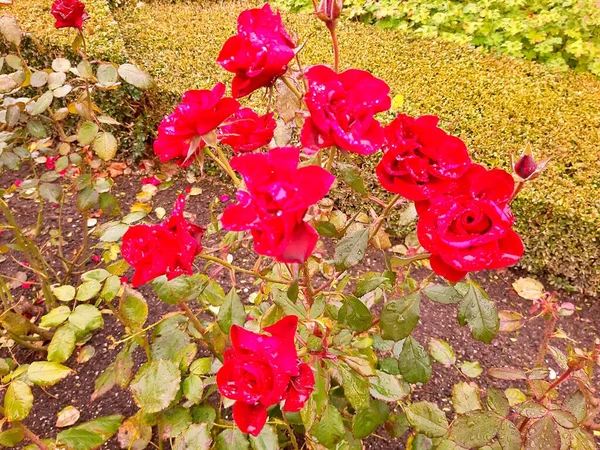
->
<box><xmin>0</xmin><ymin>167</ymin><xmax>600</xmax><ymax>450</ymax></box>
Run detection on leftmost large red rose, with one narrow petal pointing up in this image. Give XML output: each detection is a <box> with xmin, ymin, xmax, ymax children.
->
<box><xmin>121</xmin><ymin>195</ymin><xmax>204</xmax><ymax>287</ymax></box>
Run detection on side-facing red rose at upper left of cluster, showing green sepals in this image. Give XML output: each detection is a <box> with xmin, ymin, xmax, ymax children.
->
<box><xmin>154</xmin><ymin>83</ymin><xmax>240</xmax><ymax>166</ymax></box>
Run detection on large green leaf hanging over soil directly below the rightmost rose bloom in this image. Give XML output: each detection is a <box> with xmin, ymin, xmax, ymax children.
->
<box><xmin>458</xmin><ymin>283</ymin><xmax>500</xmax><ymax>344</ymax></box>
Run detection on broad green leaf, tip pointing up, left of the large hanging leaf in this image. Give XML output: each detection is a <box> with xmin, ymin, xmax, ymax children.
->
<box><xmin>380</xmin><ymin>292</ymin><xmax>421</xmax><ymax>341</ymax></box>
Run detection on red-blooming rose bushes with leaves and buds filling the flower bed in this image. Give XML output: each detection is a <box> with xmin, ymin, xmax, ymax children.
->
<box><xmin>0</xmin><ymin>0</ymin><xmax>600</xmax><ymax>450</ymax></box>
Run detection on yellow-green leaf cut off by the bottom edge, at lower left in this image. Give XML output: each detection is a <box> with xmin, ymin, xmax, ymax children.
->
<box><xmin>57</xmin><ymin>415</ymin><xmax>123</xmax><ymax>450</ymax></box>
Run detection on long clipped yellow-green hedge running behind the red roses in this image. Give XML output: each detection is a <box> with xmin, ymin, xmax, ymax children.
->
<box><xmin>10</xmin><ymin>0</ymin><xmax>600</xmax><ymax>293</ymax></box>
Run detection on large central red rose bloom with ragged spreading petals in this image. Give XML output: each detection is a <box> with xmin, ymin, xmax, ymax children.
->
<box><xmin>221</xmin><ymin>147</ymin><xmax>335</xmax><ymax>263</ymax></box>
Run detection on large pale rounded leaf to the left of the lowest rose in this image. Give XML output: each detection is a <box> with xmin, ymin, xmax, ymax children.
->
<box><xmin>130</xmin><ymin>360</ymin><xmax>181</xmax><ymax>413</ymax></box>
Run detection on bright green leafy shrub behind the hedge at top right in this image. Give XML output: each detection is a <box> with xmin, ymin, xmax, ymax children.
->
<box><xmin>279</xmin><ymin>0</ymin><xmax>600</xmax><ymax>75</ymax></box>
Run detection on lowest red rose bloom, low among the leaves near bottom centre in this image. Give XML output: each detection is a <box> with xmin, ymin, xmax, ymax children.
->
<box><xmin>217</xmin><ymin>316</ymin><xmax>315</xmax><ymax>436</ymax></box>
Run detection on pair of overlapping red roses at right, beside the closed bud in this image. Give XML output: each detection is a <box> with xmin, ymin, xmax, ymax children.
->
<box><xmin>376</xmin><ymin>115</ymin><xmax>524</xmax><ymax>281</ymax></box>
